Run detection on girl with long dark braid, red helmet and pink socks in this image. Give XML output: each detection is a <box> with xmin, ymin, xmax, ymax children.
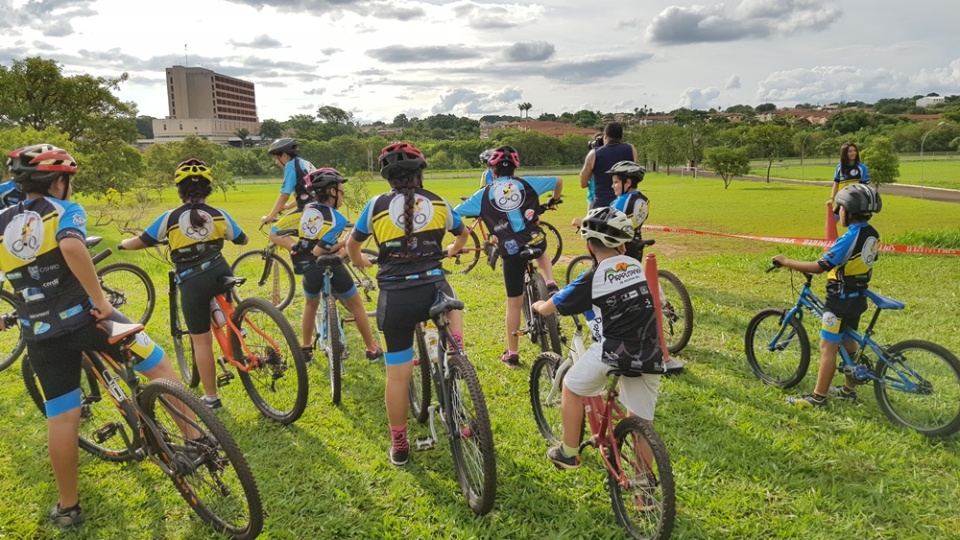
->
<box><xmin>347</xmin><ymin>142</ymin><xmax>469</xmax><ymax>467</ymax></box>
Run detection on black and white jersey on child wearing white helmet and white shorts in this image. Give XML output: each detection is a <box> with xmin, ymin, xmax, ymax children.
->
<box><xmin>553</xmin><ymin>255</ymin><xmax>664</xmax><ymax>373</ymax></box>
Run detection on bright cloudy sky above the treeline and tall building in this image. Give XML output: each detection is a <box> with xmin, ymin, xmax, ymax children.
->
<box><xmin>0</xmin><ymin>0</ymin><xmax>960</xmax><ymax>123</ymax></box>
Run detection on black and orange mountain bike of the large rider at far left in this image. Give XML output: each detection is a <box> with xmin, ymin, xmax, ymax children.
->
<box><xmin>18</xmin><ymin>314</ymin><xmax>263</xmax><ymax>539</ymax></box>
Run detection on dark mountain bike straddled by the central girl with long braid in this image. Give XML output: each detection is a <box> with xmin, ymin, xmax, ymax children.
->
<box><xmin>410</xmin><ymin>293</ymin><xmax>497</xmax><ymax>515</ymax></box>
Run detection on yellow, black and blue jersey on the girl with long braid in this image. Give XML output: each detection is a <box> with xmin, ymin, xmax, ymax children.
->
<box><xmin>353</xmin><ymin>188</ymin><xmax>463</xmax><ymax>290</ymax></box>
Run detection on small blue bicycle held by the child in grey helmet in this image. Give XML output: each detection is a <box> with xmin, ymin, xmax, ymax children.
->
<box><xmin>744</xmin><ymin>265</ymin><xmax>960</xmax><ymax>437</ymax></box>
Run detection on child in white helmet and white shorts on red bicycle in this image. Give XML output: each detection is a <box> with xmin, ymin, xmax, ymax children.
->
<box><xmin>533</xmin><ymin>208</ymin><xmax>664</xmax><ymax>469</ymax></box>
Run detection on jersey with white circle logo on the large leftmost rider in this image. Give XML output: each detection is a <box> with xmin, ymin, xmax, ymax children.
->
<box><xmin>0</xmin><ymin>197</ymin><xmax>94</xmax><ymax>341</ymax></box>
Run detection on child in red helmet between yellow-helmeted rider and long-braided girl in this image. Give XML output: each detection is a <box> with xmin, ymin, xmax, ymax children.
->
<box><xmin>270</xmin><ymin>167</ymin><xmax>383</xmax><ymax>362</ymax></box>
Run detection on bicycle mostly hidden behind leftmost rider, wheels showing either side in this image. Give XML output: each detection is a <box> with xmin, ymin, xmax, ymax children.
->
<box><xmin>0</xmin><ymin>236</ymin><xmax>156</xmax><ymax>371</ymax></box>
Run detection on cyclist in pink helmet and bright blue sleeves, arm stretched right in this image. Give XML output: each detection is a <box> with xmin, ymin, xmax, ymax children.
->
<box><xmin>454</xmin><ymin>146</ymin><xmax>563</xmax><ymax>368</ymax></box>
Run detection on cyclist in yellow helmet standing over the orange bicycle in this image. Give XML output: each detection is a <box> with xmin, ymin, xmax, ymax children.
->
<box><xmin>119</xmin><ymin>159</ymin><xmax>248</xmax><ymax>409</ymax></box>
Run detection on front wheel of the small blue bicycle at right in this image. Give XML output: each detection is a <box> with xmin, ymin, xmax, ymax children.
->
<box><xmin>743</xmin><ymin>308</ymin><xmax>810</xmax><ymax>388</ymax></box>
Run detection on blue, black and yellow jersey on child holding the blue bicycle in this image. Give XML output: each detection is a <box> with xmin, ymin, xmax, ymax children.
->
<box><xmin>817</xmin><ymin>222</ymin><xmax>880</xmax><ymax>298</ymax></box>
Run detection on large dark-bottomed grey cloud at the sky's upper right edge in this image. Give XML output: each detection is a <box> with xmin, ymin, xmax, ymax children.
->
<box><xmin>646</xmin><ymin>0</ymin><xmax>842</xmax><ymax>45</ymax></box>
